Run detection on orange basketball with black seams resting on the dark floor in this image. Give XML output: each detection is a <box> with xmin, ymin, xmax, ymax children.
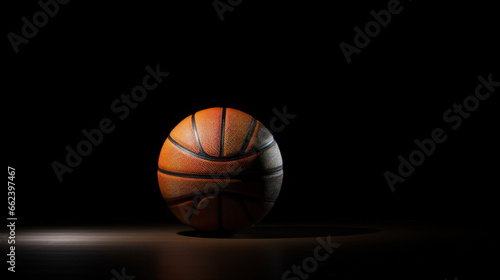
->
<box><xmin>158</xmin><ymin>108</ymin><xmax>283</xmax><ymax>232</ymax></box>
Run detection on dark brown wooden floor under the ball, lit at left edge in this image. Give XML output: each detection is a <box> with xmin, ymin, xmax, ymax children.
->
<box><xmin>10</xmin><ymin>224</ymin><xmax>498</xmax><ymax>280</ymax></box>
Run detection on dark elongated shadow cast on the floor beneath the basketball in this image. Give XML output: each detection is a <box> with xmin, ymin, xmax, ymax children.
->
<box><xmin>177</xmin><ymin>226</ymin><xmax>380</xmax><ymax>239</ymax></box>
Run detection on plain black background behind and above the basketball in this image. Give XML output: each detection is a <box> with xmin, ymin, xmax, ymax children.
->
<box><xmin>3</xmin><ymin>0</ymin><xmax>500</xmax><ymax>230</ymax></box>
